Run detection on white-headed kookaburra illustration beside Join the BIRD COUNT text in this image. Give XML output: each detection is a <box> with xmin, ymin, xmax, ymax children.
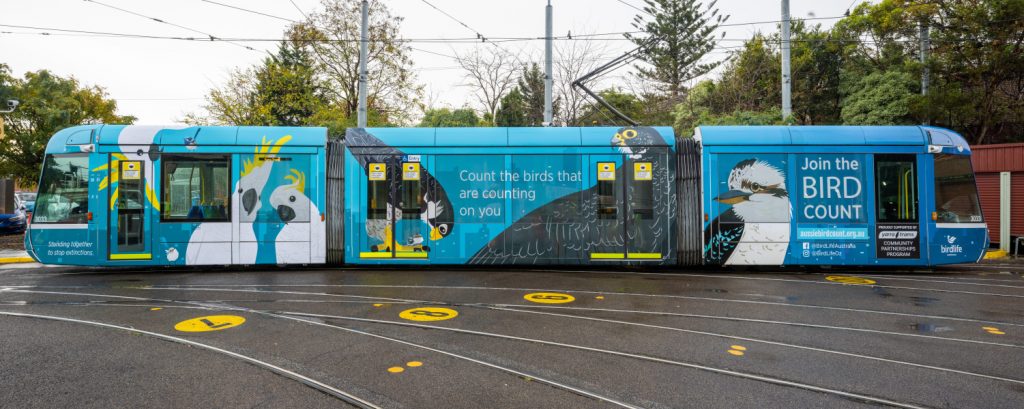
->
<box><xmin>705</xmin><ymin>159</ymin><xmax>792</xmax><ymax>265</ymax></box>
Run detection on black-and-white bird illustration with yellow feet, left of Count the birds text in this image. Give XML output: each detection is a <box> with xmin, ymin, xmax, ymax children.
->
<box><xmin>345</xmin><ymin>128</ymin><xmax>455</xmax><ymax>251</ymax></box>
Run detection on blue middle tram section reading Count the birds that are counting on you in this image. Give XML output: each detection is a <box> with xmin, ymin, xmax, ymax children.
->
<box><xmin>345</xmin><ymin>128</ymin><xmax>675</xmax><ymax>264</ymax></box>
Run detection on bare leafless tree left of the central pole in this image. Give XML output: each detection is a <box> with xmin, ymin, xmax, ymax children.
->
<box><xmin>456</xmin><ymin>47</ymin><xmax>516</xmax><ymax>125</ymax></box>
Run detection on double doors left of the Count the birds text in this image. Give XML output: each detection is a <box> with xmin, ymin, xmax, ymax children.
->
<box><xmin>359</xmin><ymin>156</ymin><xmax>431</xmax><ymax>259</ymax></box>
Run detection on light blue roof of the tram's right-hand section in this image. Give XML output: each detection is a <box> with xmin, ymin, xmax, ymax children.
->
<box><xmin>697</xmin><ymin>125</ymin><xmax>969</xmax><ymax>150</ymax></box>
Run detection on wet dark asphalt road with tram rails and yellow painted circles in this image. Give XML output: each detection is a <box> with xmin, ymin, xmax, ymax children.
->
<box><xmin>0</xmin><ymin>267</ymin><xmax>1024</xmax><ymax>408</ymax></box>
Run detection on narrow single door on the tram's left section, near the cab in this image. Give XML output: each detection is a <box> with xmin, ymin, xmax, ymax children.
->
<box><xmin>106</xmin><ymin>156</ymin><xmax>153</xmax><ymax>260</ymax></box>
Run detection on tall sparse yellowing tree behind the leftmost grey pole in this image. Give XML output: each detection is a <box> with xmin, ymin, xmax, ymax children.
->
<box><xmin>288</xmin><ymin>0</ymin><xmax>423</xmax><ymax>125</ymax></box>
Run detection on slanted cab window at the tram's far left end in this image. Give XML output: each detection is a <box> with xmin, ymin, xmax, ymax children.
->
<box><xmin>32</xmin><ymin>155</ymin><xmax>89</xmax><ymax>223</ymax></box>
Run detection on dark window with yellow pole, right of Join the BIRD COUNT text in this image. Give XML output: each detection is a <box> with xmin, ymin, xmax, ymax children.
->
<box><xmin>874</xmin><ymin>155</ymin><xmax>918</xmax><ymax>222</ymax></box>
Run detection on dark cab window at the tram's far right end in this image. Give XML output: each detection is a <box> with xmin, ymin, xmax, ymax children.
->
<box><xmin>935</xmin><ymin>155</ymin><xmax>983</xmax><ymax>222</ymax></box>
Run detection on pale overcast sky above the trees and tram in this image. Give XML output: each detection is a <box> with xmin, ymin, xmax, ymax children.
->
<box><xmin>0</xmin><ymin>0</ymin><xmax>853</xmax><ymax>124</ymax></box>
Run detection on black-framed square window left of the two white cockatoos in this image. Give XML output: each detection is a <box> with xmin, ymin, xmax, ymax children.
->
<box><xmin>160</xmin><ymin>155</ymin><xmax>230</xmax><ymax>221</ymax></box>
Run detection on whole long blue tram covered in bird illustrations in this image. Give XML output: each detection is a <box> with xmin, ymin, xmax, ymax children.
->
<box><xmin>26</xmin><ymin>125</ymin><xmax>988</xmax><ymax>265</ymax></box>
